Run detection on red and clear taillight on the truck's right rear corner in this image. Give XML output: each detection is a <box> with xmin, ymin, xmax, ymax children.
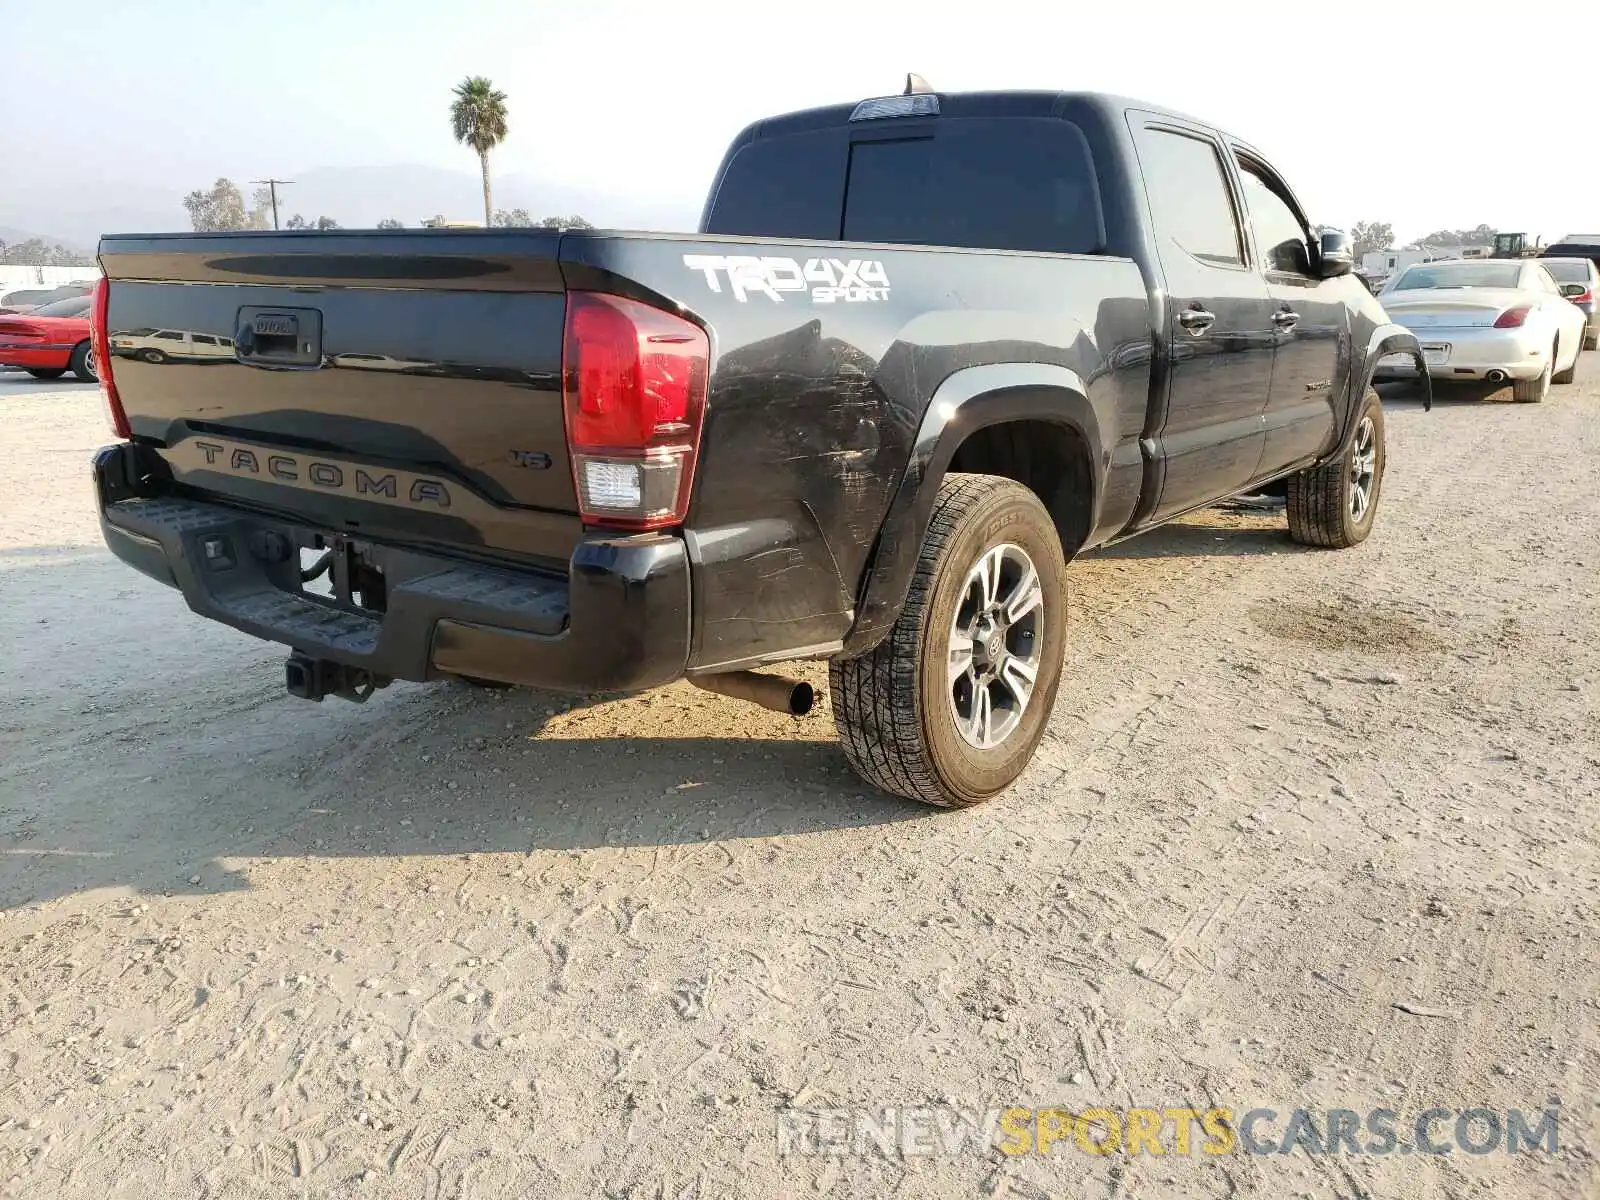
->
<box><xmin>562</xmin><ymin>291</ymin><xmax>710</xmax><ymax>530</ymax></box>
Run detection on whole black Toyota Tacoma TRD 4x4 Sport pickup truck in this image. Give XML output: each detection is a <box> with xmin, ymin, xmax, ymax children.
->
<box><xmin>94</xmin><ymin>91</ymin><xmax>1426</xmax><ymax>806</ymax></box>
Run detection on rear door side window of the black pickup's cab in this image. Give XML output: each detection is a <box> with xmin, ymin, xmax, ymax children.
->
<box><xmin>1139</xmin><ymin>130</ymin><xmax>1245</xmax><ymax>267</ymax></box>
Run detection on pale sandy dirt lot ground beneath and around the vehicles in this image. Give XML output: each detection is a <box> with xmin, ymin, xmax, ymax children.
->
<box><xmin>0</xmin><ymin>369</ymin><xmax>1600</xmax><ymax>1200</ymax></box>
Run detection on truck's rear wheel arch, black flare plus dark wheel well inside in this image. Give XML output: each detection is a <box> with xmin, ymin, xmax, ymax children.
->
<box><xmin>843</xmin><ymin>363</ymin><xmax>1107</xmax><ymax>656</ymax></box>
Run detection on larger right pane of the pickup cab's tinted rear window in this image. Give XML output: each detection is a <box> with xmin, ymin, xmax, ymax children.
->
<box><xmin>843</xmin><ymin>118</ymin><xmax>1106</xmax><ymax>254</ymax></box>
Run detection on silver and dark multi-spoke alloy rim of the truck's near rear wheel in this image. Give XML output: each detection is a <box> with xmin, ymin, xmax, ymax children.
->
<box><xmin>946</xmin><ymin>542</ymin><xmax>1045</xmax><ymax>750</ymax></box>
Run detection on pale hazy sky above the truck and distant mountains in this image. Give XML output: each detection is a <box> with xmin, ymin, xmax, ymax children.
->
<box><xmin>0</xmin><ymin>0</ymin><xmax>1600</xmax><ymax>240</ymax></box>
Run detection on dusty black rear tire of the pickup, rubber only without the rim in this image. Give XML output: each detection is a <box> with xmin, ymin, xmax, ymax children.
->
<box><xmin>829</xmin><ymin>474</ymin><xmax>1067</xmax><ymax>808</ymax></box>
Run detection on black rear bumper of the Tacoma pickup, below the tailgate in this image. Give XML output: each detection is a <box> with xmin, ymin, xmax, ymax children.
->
<box><xmin>94</xmin><ymin>446</ymin><xmax>690</xmax><ymax>693</ymax></box>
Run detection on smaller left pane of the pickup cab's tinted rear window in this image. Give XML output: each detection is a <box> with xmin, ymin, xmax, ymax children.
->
<box><xmin>706</xmin><ymin>130</ymin><xmax>850</xmax><ymax>242</ymax></box>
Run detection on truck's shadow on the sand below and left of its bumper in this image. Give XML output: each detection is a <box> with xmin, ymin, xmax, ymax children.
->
<box><xmin>0</xmin><ymin>668</ymin><xmax>934</xmax><ymax>909</ymax></box>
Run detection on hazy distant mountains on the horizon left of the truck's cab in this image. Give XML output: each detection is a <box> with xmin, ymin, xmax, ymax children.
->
<box><xmin>0</xmin><ymin>165</ymin><xmax>701</xmax><ymax>250</ymax></box>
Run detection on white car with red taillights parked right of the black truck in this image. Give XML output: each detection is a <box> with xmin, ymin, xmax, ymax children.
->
<box><xmin>1378</xmin><ymin>258</ymin><xmax>1584</xmax><ymax>402</ymax></box>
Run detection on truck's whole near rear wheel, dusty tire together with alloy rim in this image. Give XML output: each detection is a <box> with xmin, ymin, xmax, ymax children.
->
<box><xmin>829</xmin><ymin>474</ymin><xmax>1067</xmax><ymax>808</ymax></box>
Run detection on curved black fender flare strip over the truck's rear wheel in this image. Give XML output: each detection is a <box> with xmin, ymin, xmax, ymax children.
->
<box><xmin>843</xmin><ymin>363</ymin><xmax>1106</xmax><ymax>658</ymax></box>
